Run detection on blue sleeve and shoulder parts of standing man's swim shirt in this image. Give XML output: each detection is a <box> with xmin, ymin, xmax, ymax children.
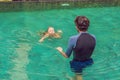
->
<box><xmin>66</xmin><ymin>32</ymin><xmax>95</xmax><ymax>57</ymax></box>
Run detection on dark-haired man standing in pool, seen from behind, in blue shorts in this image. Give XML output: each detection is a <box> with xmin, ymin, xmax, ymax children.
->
<box><xmin>56</xmin><ymin>16</ymin><xmax>96</xmax><ymax>80</ymax></box>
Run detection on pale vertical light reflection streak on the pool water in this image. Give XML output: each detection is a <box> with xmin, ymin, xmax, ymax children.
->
<box><xmin>10</xmin><ymin>43</ymin><xmax>31</xmax><ymax>80</ymax></box>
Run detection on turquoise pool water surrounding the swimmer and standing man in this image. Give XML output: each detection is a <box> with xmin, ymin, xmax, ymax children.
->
<box><xmin>0</xmin><ymin>7</ymin><xmax>120</xmax><ymax>80</ymax></box>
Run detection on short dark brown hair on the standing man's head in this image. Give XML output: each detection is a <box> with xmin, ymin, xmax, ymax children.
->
<box><xmin>75</xmin><ymin>16</ymin><xmax>90</xmax><ymax>31</ymax></box>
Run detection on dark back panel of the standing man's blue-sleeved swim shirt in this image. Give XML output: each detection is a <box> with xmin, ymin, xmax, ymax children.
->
<box><xmin>73</xmin><ymin>33</ymin><xmax>96</xmax><ymax>61</ymax></box>
